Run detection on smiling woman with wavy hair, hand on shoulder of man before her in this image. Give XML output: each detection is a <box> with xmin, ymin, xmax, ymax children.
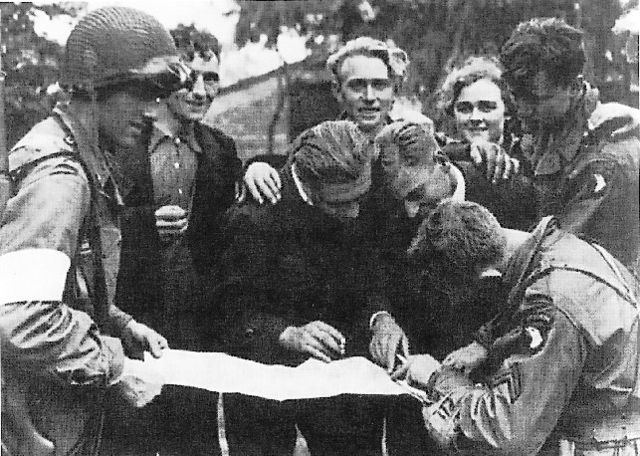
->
<box><xmin>438</xmin><ymin>56</ymin><xmax>535</xmax><ymax>229</ymax></box>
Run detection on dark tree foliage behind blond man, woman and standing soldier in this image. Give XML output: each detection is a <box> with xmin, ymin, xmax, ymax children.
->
<box><xmin>237</xmin><ymin>0</ymin><xmax>638</xmax><ymax>116</ymax></box>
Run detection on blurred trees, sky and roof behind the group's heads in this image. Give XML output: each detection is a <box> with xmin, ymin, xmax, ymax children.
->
<box><xmin>0</xmin><ymin>0</ymin><xmax>640</xmax><ymax>159</ymax></box>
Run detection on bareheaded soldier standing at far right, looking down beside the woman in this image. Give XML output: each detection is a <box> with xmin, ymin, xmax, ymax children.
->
<box><xmin>500</xmin><ymin>18</ymin><xmax>640</xmax><ymax>271</ymax></box>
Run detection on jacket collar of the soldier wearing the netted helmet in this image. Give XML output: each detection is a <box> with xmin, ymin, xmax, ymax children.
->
<box><xmin>53</xmin><ymin>106</ymin><xmax>124</xmax><ymax>206</ymax></box>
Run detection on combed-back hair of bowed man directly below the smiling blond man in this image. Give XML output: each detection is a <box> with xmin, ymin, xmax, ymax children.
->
<box><xmin>292</xmin><ymin>120</ymin><xmax>373</xmax><ymax>185</ymax></box>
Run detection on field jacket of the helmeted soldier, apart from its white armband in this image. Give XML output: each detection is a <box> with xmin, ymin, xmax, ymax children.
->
<box><xmin>0</xmin><ymin>110</ymin><xmax>131</xmax><ymax>454</ymax></box>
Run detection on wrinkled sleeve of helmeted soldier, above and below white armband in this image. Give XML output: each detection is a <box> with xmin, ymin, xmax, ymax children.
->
<box><xmin>0</xmin><ymin>156</ymin><xmax>123</xmax><ymax>384</ymax></box>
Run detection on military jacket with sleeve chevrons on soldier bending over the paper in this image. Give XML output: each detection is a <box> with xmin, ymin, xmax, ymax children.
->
<box><xmin>424</xmin><ymin>218</ymin><xmax>640</xmax><ymax>455</ymax></box>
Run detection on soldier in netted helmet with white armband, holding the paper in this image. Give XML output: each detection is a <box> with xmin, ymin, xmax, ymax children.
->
<box><xmin>0</xmin><ymin>7</ymin><xmax>187</xmax><ymax>455</ymax></box>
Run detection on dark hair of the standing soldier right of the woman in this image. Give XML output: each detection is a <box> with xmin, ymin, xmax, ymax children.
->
<box><xmin>500</xmin><ymin>18</ymin><xmax>585</xmax><ymax>90</ymax></box>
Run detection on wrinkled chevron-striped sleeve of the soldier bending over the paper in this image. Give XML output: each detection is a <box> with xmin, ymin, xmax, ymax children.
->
<box><xmin>423</xmin><ymin>298</ymin><xmax>587</xmax><ymax>455</ymax></box>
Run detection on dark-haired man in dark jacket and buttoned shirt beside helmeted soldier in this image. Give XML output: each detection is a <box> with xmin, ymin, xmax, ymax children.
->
<box><xmin>113</xmin><ymin>27</ymin><xmax>241</xmax><ymax>455</ymax></box>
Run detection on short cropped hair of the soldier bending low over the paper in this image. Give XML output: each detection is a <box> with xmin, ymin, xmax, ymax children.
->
<box><xmin>408</xmin><ymin>199</ymin><xmax>506</xmax><ymax>275</ymax></box>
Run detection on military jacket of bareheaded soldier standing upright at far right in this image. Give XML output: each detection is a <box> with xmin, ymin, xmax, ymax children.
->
<box><xmin>516</xmin><ymin>85</ymin><xmax>640</xmax><ymax>272</ymax></box>
